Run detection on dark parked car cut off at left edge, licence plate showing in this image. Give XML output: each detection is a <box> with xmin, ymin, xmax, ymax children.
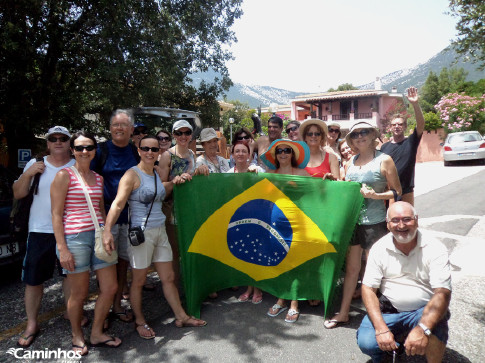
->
<box><xmin>0</xmin><ymin>165</ymin><xmax>27</xmax><ymax>267</ymax></box>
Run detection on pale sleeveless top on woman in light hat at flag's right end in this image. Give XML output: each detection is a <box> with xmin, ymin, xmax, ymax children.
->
<box><xmin>345</xmin><ymin>150</ymin><xmax>387</xmax><ymax>225</ymax></box>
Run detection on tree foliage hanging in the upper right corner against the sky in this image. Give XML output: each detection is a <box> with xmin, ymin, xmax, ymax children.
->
<box><xmin>450</xmin><ymin>0</ymin><xmax>485</xmax><ymax>69</ymax></box>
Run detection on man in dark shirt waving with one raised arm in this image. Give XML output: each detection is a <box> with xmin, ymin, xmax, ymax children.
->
<box><xmin>381</xmin><ymin>87</ymin><xmax>425</xmax><ymax>205</ymax></box>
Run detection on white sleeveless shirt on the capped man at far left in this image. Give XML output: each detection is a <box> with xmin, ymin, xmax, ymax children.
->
<box><xmin>20</xmin><ymin>156</ymin><xmax>75</xmax><ymax>233</ymax></box>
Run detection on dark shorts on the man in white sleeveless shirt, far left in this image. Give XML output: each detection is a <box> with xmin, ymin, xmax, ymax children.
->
<box><xmin>22</xmin><ymin>232</ymin><xmax>62</xmax><ymax>286</ymax></box>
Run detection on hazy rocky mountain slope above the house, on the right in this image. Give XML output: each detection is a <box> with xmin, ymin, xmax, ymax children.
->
<box><xmin>357</xmin><ymin>48</ymin><xmax>485</xmax><ymax>92</ymax></box>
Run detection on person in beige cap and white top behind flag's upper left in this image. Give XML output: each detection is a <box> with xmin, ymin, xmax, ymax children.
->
<box><xmin>195</xmin><ymin>127</ymin><xmax>230</xmax><ymax>175</ymax></box>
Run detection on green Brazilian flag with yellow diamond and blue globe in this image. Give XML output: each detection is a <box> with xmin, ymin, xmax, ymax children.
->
<box><xmin>174</xmin><ymin>173</ymin><xmax>363</xmax><ymax>317</ymax></box>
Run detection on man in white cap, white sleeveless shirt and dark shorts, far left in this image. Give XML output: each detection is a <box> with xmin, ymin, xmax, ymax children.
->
<box><xmin>13</xmin><ymin>126</ymin><xmax>74</xmax><ymax>348</ymax></box>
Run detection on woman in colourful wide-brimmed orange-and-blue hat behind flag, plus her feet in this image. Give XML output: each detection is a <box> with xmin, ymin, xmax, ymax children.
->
<box><xmin>261</xmin><ymin>139</ymin><xmax>310</xmax><ymax>323</ymax></box>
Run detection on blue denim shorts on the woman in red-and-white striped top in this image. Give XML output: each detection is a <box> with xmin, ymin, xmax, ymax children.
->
<box><xmin>56</xmin><ymin>230</ymin><xmax>116</xmax><ymax>274</ymax></box>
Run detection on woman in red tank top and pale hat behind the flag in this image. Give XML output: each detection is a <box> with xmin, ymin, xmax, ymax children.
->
<box><xmin>300</xmin><ymin>119</ymin><xmax>340</xmax><ymax>180</ymax></box>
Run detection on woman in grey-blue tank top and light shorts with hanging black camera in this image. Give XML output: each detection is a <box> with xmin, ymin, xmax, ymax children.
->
<box><xmin>104</xmin><ymin>135</ymin><xmax>206</xmax><ymax>339</ymax></box>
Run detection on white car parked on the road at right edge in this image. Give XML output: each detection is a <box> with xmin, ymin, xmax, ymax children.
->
<box><xmin>442</xmin><ymin>131</ymin><xmax>485</xmax><ymax>166</ymax></box>
